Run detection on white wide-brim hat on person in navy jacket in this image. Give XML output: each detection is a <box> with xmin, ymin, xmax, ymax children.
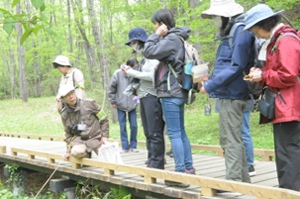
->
<box><xmin>201</xmin><ymin>0</ymin><xmax>244</xmax><ymax>19</ymax></box>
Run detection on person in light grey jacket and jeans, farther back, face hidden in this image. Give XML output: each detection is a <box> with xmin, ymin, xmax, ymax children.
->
<box><xmin>108</xmin><ymin>60</ymin><xmax>138</xmax><ymax>153</ymax></box>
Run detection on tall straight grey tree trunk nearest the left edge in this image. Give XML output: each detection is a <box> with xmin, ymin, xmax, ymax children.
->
<box><xmin>16</xmin><ymin>3</ymin><xmax>28</xmax><ymax>102</ymax></box>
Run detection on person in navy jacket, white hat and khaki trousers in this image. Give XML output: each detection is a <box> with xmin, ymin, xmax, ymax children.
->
<box><xmin>200</xmin><ymin>0</ymin><xmax>254</xmax><ymax>193</ymax></box>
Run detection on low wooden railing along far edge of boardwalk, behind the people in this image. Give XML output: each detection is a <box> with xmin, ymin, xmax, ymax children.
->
<box><xmin>0</xmin><ymin>132</ymin><xmax>275</xmax><ymax>161</ymax></box>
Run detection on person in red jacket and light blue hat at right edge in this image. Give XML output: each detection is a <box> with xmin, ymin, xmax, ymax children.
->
<box><xmin>244</xmin><ymin>4</ymin><xmax>300</xmax><ymax>191</ymax></box>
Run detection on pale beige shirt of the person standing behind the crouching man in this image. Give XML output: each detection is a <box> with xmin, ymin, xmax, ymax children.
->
<box><xmin>56</xmin><ymin>68</ymin><xmax>85</xmax><ymax>99</ymax></box>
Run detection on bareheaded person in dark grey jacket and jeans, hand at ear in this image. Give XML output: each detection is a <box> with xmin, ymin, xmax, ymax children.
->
<box><xmin>144</xmin><ymin>9</ymin><xmax>195</xmax><ymax>187</ymax></box>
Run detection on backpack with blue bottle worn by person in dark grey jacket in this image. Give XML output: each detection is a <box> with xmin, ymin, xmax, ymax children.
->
<box><xmin>168</xmin><ymin>36</ymin><xmax>201</xmax><ymax>104</ymax></box>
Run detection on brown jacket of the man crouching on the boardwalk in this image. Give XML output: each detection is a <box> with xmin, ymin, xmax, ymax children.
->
<box><xmin>61</xmin><ymin>98</ymin><xmax>109</xmax><ymax>153</ymax></box>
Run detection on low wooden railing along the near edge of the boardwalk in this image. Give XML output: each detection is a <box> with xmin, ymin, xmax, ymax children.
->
<box><xmin>0</xmin><ymin>146</ymin><xmax>300</xmax><ymax>199</ymax></box>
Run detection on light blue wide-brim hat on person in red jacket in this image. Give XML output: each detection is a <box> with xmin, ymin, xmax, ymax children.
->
<box><xmin>242</xmin><ymin>4</ymin><xmax>284</xmax><ymax>32</ymax></box>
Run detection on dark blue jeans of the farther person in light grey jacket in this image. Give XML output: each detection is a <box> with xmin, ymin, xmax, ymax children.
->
<box><xmin>117</xmin><ymin>109</ymin><xmax>137</xmax><ymax>150</ymax></box>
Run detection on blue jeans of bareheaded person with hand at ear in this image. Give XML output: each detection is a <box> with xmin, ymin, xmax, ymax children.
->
<box><xmin>161</xmin><ymin>97</ymin><xmax>193</xmax><ymax>172</ymax></box>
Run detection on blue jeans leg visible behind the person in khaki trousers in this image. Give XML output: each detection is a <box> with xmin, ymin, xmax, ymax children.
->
<box><xmin>242</xmin><ymin>111</ymin><xmax>254</xmax><ymax>168</ymax></box>
